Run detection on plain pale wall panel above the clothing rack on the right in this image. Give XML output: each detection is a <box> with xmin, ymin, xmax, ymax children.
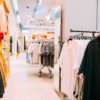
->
<box><xmin>64</xmin><ymin>0</ymin><xmax>96</xmax><ymax>37</ymax></box>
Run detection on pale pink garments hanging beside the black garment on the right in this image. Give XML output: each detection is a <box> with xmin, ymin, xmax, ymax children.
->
<box><xmin>58</xmin><ymin>40</ymin><xmax>89</xmax><ymax>100</ymax></box>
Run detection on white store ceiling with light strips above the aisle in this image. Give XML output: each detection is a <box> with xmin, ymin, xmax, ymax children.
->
<box><xmin>13</xmin><ymin>0</ymin><xmax>54</xmax><ymax>29</ymax></box>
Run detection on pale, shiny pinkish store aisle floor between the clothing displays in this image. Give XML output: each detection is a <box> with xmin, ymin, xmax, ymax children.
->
<box><xmin>1</xmin><ymin>55</ymin><xmax>61</xmax><ymax>100</ymax></box>
